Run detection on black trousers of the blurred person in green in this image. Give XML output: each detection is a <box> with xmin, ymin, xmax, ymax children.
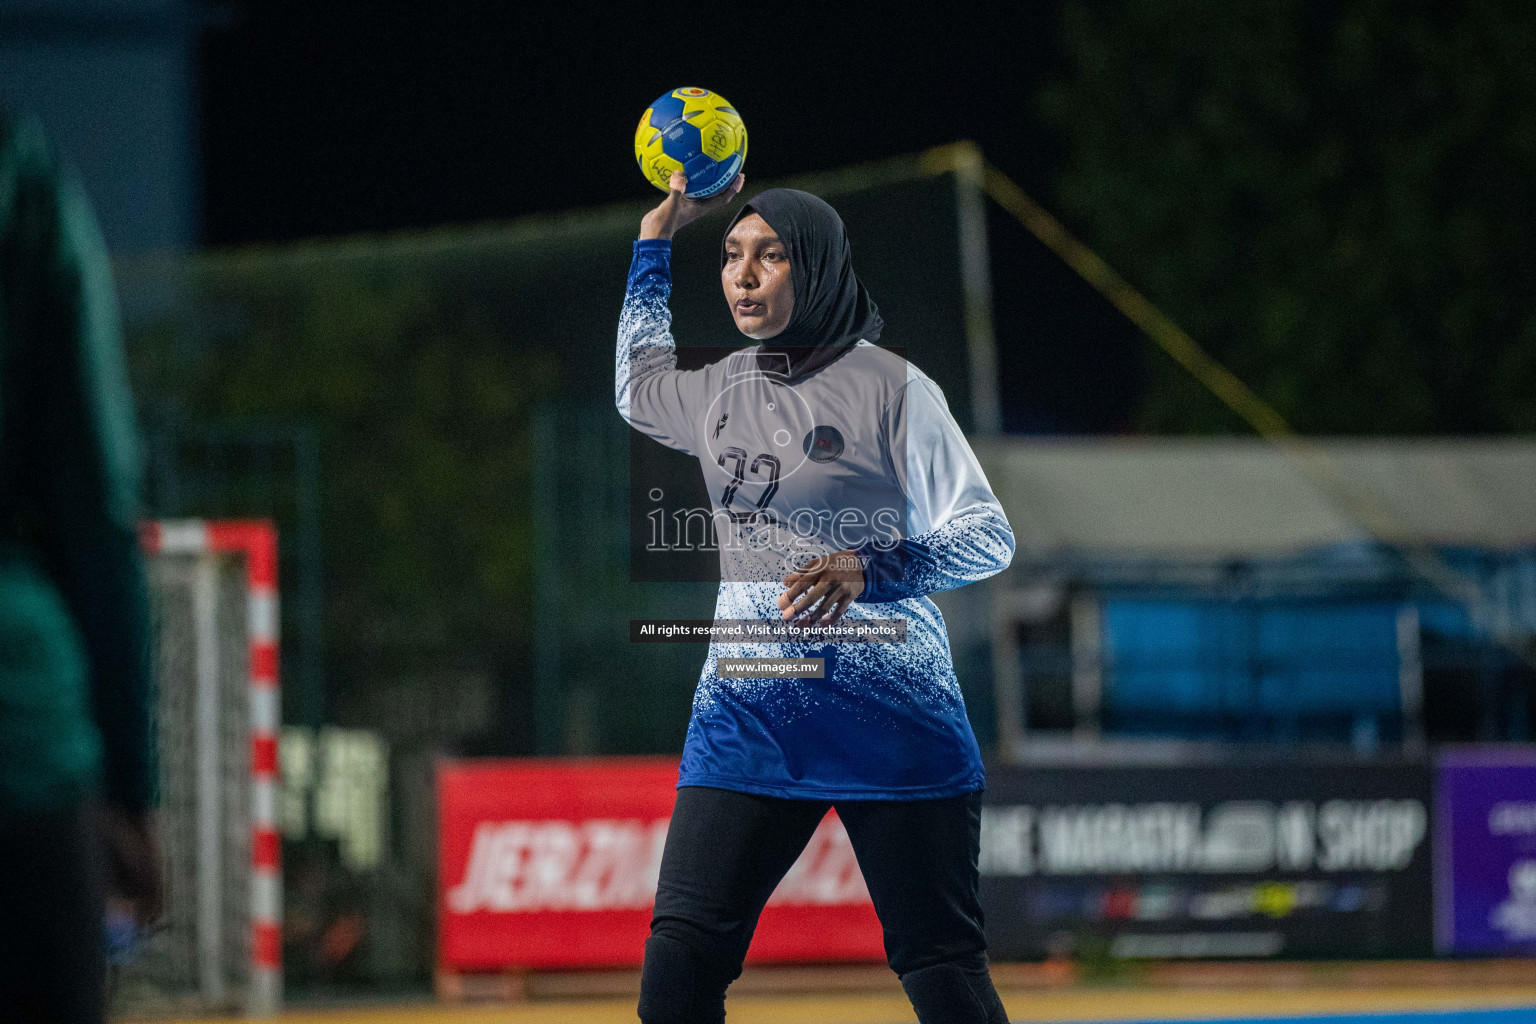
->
<box><xmin>0</xmin><ymin>808</ymin><xmax>106</xmax><ymax>1024</ymax></box>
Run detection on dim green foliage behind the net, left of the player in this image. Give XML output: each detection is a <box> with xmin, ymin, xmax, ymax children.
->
<box><xmin>131</xmin><ymin>259</ymin><xmax>559</xmax><ymax>727</ymax></box>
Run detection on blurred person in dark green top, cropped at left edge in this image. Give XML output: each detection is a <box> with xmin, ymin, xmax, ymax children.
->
<box><xmin>0</xmin><ymin>109</ymin><xmax>161</xmax><ymax>1024</ymax></box>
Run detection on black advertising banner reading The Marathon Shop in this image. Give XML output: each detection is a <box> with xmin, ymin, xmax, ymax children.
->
<box><xmin>982</xmin><ymin>758</ymin><xmax>1433</xmax><ymax>960</ymax></box>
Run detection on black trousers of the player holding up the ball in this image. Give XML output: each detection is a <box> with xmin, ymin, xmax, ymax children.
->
<box><xmin>641</xmin><ymin>786</ymin><xmax>1008</xmax><ymax>1024</ymax></box>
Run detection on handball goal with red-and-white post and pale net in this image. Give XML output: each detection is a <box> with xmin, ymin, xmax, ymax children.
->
<box><xmin>112</xmin><ymin>520</ymin><xmax>281</xmax><ymax>1016</ymax></box>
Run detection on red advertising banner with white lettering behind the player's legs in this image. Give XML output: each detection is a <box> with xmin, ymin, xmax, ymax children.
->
<box><xmin>438</xmin><ymin>757</ymin><xmax>885</xmax><ymax>972</ymax></box>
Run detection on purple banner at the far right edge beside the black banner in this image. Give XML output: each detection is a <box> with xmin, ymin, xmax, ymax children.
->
<box><xmin>1435</xmin><ymin>746</ymin><xmax>1536</xmax><ymax>953</ymax></box>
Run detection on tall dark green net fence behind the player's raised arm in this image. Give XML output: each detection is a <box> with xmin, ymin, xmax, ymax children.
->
<box><xmin>118</xmin><ymin>151</ymin><xmax>972</xmax><ymax>752</ymax></box>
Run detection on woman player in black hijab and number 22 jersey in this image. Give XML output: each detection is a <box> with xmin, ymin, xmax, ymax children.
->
<box><xmin>614</xmin><ymin>173</ymin><xmax>1014</xmax><ymax>1024</ymax></box>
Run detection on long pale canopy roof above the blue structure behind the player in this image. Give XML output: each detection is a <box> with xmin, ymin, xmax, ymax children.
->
<box><xmin>975</xmin><ymin>438</ymin><xmax>1536</xmax><ymax>557</ymax></box>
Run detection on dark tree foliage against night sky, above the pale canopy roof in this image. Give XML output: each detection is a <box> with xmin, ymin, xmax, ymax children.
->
<box><xmin>1040</xmin><ymin>0</ymin><xmax>1536</xmax><ymax>433</ymax></box>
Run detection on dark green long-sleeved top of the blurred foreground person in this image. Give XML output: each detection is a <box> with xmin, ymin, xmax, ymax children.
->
<box><xmin>0</xmin><ymin>112</ymin><xmax>155</xmax><ymax>818</ymax></box>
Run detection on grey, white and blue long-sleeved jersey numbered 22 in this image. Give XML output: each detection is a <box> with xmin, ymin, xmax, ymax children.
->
<box><xmin>614</xmin><ymin>239</ymin><xmax>1014</xmax><ymax>800</ymax></box>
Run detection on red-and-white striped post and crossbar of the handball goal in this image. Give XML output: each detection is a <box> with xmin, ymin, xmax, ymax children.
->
<box><xmin>140</xmin><ymin>519</ymin><xmax>283</xmax><ymax>1015</ymax></box>
